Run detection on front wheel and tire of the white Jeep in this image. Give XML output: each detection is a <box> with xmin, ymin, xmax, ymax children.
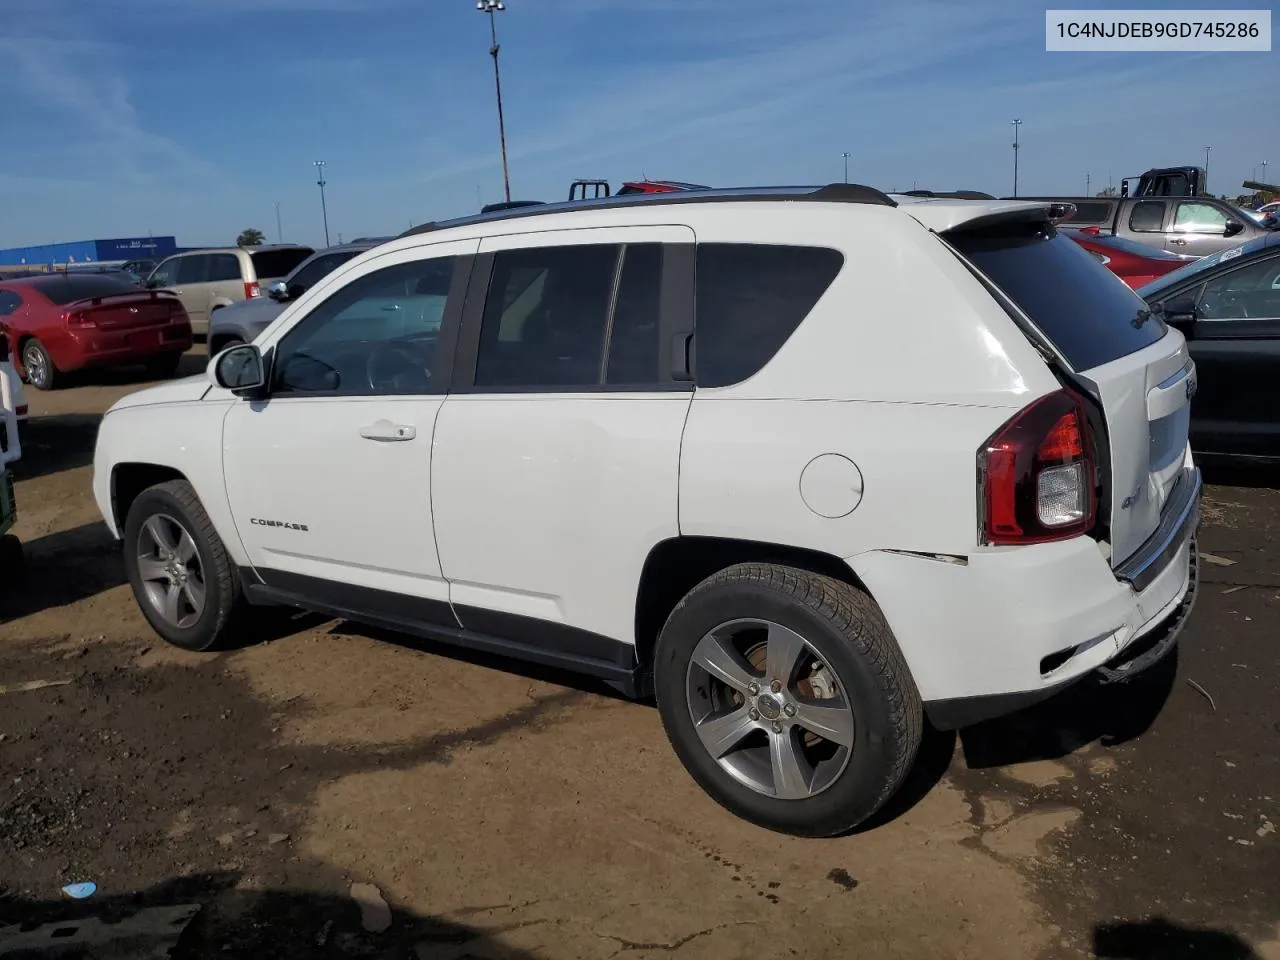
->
<box><xmin>124</xmin><ymin>480</ymin><xmax>244</xmax><ymax>652</ymax></box>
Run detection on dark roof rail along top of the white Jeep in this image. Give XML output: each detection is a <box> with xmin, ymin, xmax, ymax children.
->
<box><xmin>399</xmin><ymin>183</ymin><xmax>897</xmax><ymax>237</ymax></box>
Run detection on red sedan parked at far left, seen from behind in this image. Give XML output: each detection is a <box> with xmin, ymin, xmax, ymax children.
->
<box><xmin>0</xmin><ymin>273</ymin><xmax>191</xmax><ymax>390</ymax></box>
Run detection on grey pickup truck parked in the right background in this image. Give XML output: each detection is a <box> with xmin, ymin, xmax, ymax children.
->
<box><xmin>1019</xmin><ymin>196</ymin><xmax>1275</xmax><ymax>257</ymax></box>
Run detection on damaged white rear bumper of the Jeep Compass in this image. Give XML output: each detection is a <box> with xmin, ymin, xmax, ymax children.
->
<box><xmin>849</xmin><ymin>471</ymin><xmax>1201</xmax><ymax>730</ymax></box>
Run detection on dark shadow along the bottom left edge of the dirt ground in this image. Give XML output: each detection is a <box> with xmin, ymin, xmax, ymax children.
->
<box><xmin>0</xmin><ymin>870</ymin><xmax>531</xmax><ymax>960</ymax></box>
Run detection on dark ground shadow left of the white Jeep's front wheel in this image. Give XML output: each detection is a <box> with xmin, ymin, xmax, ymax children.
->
<box><xmin>0</xmin><ymin>522</ymin><xmax>127</xmax><ymax>623</ymax></box>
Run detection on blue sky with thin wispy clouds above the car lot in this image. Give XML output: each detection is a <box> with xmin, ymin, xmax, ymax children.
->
<box><xmin>0</xmin><ymin>0</ymin><xmax>1280</xmax><ymax>246</ymax></box>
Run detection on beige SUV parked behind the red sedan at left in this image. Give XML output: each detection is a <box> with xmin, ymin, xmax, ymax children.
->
<box><xmin>143</xmin><ymin>243</ymin><xmax>315</xmax><ymax>334</ymax></box>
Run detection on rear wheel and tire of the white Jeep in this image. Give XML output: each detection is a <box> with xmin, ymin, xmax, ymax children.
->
<box><xmin>654</xmin><ymin>563</ymin><xmax>924</xmax><ymax>837</ymax></box>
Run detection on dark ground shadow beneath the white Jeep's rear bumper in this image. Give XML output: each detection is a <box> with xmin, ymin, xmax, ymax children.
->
<box><xmin>960</xmin><ymin>646</ymin><xmax>1178</xmax><ymax>769</ymax></box>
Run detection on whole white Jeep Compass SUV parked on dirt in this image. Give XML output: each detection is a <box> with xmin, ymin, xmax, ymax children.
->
<box><xmin>93</xmin><ymin>184</ymin><xmax>1201</xmax><ymax>836</ymax></box>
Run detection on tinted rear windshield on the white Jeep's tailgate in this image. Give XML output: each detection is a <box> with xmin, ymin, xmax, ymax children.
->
<box><xmin>952</xmin><ymin>224</ymin><xmax>1166</xmax><ymax>371</ymax></box>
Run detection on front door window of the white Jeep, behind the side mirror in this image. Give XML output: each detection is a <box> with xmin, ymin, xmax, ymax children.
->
<box><xmin>271</xmin><ymin>257</ymin><xmax>457</xmax><ymax>397</ymax></box>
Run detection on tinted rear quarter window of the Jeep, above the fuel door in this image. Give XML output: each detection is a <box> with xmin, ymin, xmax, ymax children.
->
<box><xmin>694</xmin><ymin>241</ymin><xmax>844</xmax><ymax>387</ymax></box>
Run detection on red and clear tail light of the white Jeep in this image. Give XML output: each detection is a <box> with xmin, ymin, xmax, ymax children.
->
<box><xmin>978</xmin><ymin>390</ymin><xmax>1097</xmax><ymax>544</ymax></box>
